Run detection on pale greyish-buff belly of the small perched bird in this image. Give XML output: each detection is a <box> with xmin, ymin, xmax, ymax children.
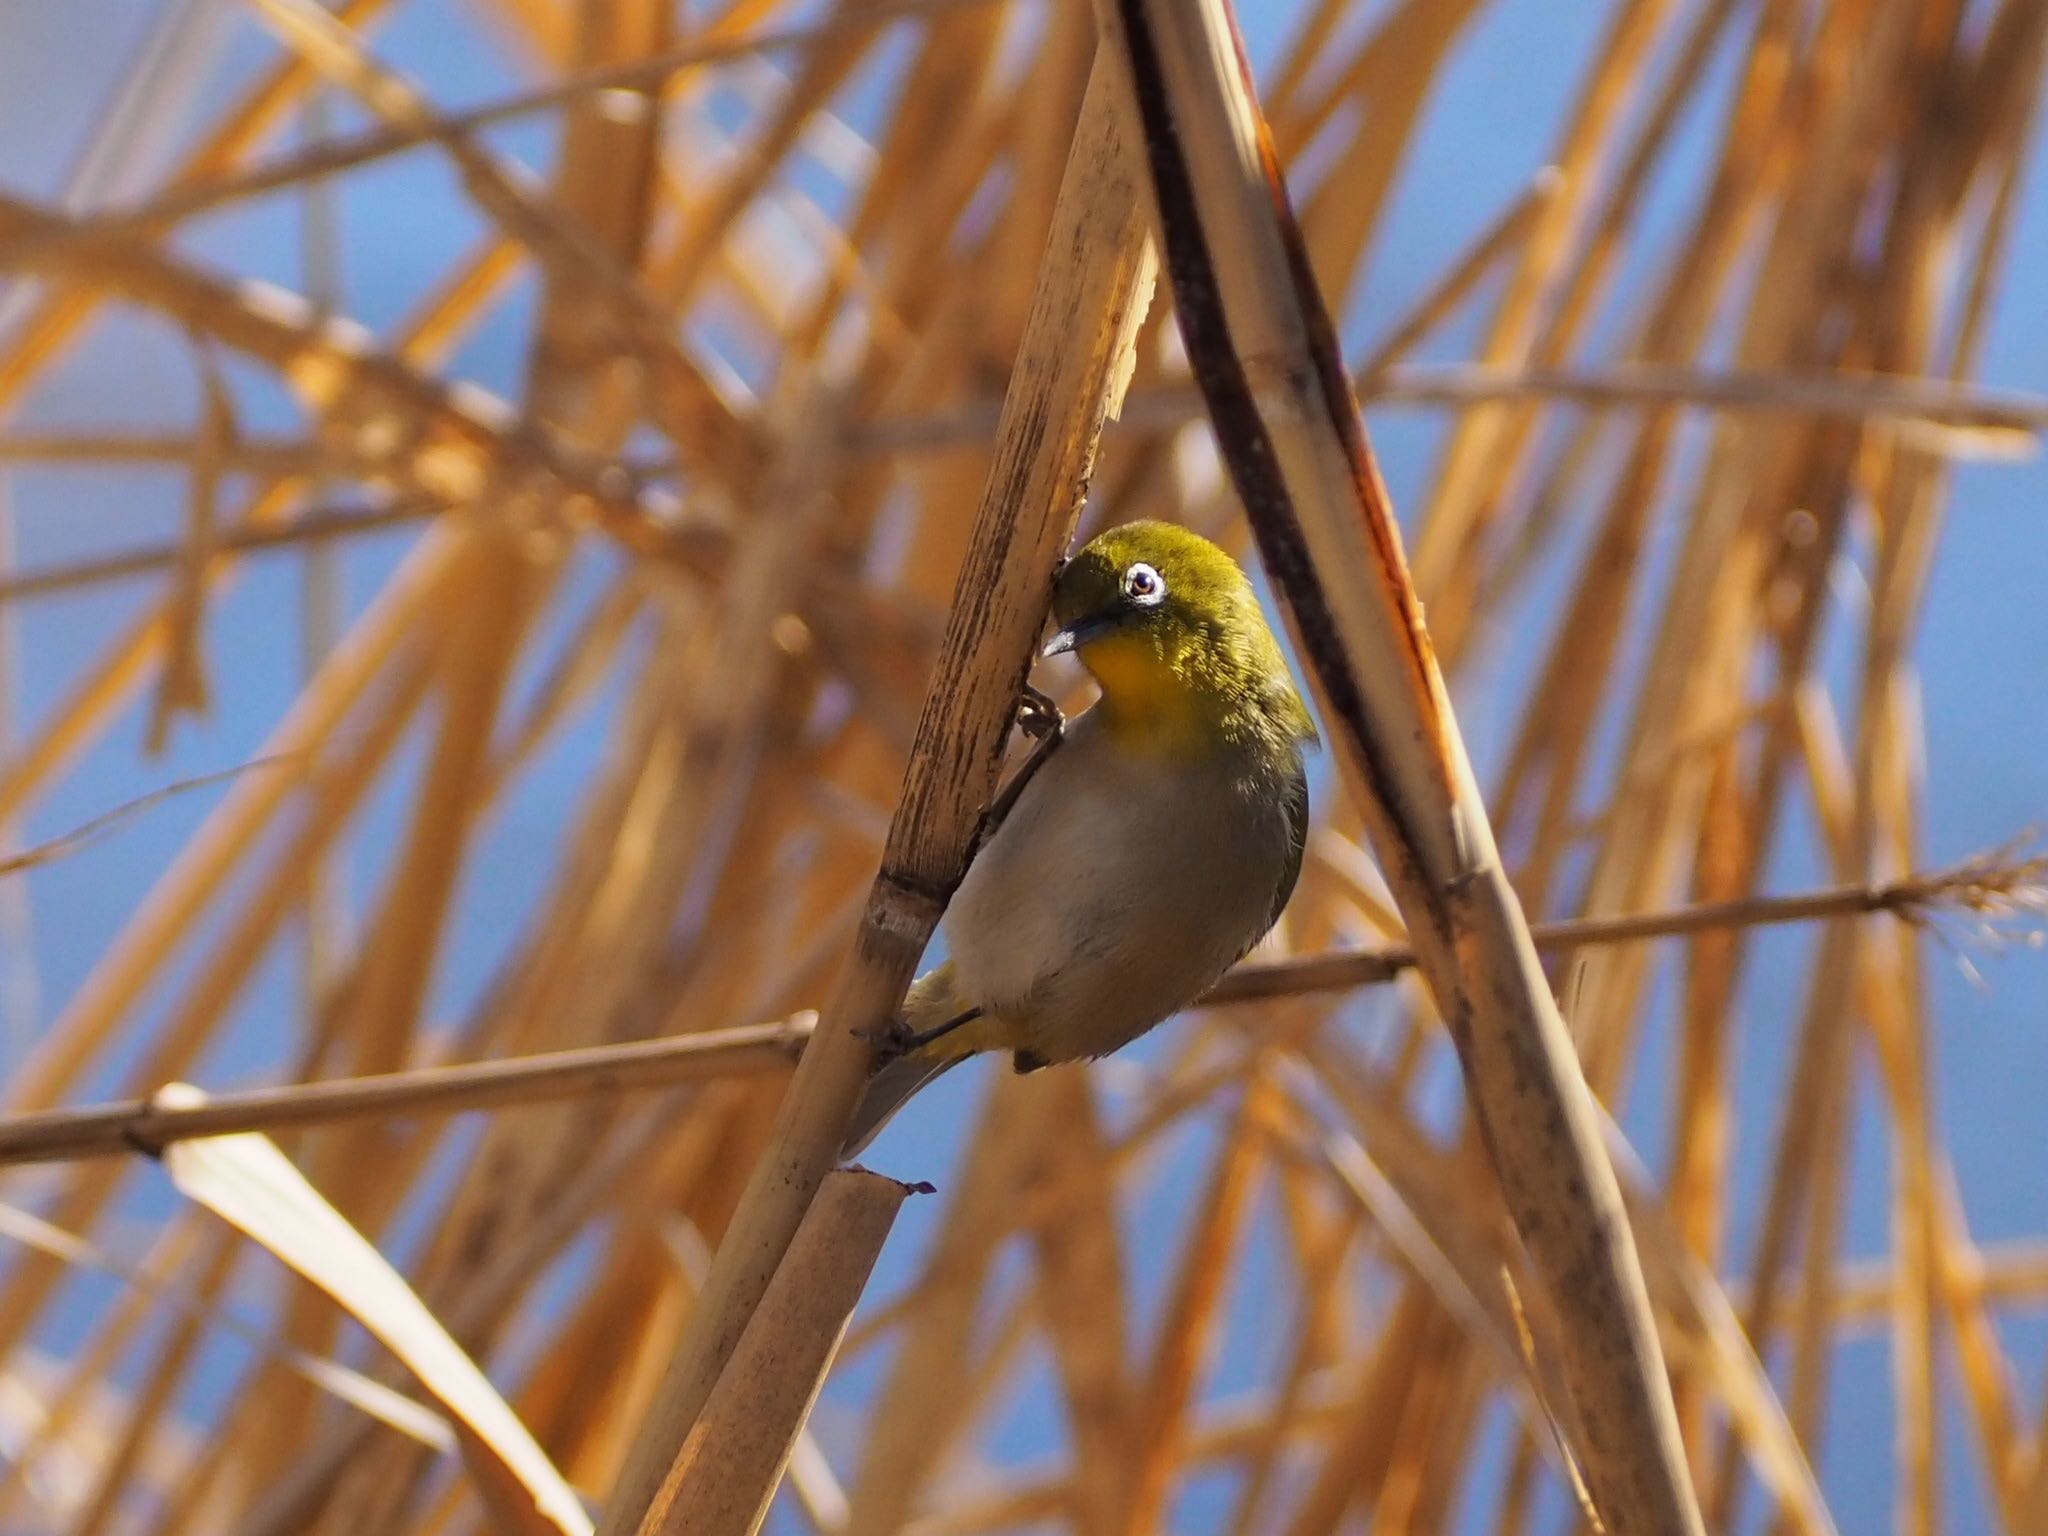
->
<box><xmin>946</xmin><ymin>737</ymin><xmax>1292</xmax><ymax>1061</ymax></box>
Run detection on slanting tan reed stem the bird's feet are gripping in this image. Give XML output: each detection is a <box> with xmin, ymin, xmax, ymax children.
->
<box><xmin>600</xmin><ymin>63</ymin><xmax>1153</xmax><ymax>1536</ymax></box>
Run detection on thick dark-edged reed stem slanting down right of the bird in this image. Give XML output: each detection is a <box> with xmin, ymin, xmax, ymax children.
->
<box><xmin>1098</xmin><ymin>0</ymin><xmax>1702</xmax><ymax>1536</ymax></box>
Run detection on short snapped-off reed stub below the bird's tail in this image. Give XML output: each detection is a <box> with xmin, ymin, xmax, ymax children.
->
<box><xmin>639</xmin><ymin>1167</ymin><xmax>932</xmax><ymax>1536</ymax></box>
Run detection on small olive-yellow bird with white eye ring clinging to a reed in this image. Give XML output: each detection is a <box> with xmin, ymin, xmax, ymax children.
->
<box><xmin>842</xmin><ymin>520</ymin><xmax>1317</xmax><ymax>1157</ymax></box>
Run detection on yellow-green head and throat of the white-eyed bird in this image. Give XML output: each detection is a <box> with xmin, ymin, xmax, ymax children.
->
<box><xmin>1044</xmin><ymin>522</ymin><xmax>1315</xmax><ymax>752</ymax></box>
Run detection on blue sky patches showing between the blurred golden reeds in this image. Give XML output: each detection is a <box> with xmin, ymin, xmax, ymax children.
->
<box><xmin>0</xmin><ymin>0</ymin><xmax>2048</xmax><ymax>1532</ymax></box>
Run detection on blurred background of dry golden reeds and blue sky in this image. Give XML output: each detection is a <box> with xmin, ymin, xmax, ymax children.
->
<box><xmin>0</xmin><ymin>0</ymin><xmax>2048</xmax><ymax>1536</ymax></box>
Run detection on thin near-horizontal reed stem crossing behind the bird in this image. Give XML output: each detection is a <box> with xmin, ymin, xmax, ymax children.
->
<box><xmin>0</xmin><ymin>860</ymin><xmax>2023</xmax><ymax>1167</ymax></box>
